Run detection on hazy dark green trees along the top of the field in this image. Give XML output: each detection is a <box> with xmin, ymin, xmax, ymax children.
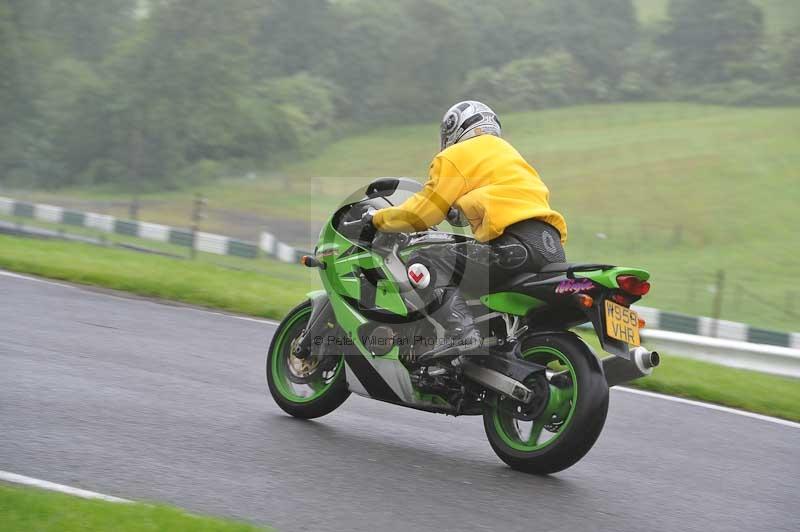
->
<box><xmin>0</xmin><ymin>0</ymin><xmax>800</xmax><ymax>189</ymax></box>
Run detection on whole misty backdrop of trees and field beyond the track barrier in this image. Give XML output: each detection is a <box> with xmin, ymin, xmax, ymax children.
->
<box><xmin>0</xmin><ymin>0</ymin><xmax>800</xmax><ymax>331</ymax></box>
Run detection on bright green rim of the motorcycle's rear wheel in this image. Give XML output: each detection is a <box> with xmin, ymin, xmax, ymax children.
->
<box><xmin>492</xmin><ymin>346</ymin><xmax>578</xmax><ymax>452</ymax></box>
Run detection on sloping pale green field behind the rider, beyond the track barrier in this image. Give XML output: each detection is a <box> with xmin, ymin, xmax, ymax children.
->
<box><xmin>17</xmin><ymin>103</ymin><xmax>800</xmax><ymax>331</ymax></box>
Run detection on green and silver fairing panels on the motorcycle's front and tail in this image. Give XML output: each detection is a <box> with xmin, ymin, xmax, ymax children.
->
<box><xmin>309</xmin><ymin>179</ymin><xmax>649</xmax><ymax>413</ymax></box>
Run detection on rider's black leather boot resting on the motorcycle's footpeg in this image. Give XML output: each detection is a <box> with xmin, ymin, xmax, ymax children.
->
<box><xmin>419</xmin><ymin>288</ymin><xmax>481</xmax><ymax>363</ymax></box>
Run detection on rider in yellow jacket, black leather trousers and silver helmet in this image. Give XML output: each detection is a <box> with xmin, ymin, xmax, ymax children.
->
<box><xmin>371</xmin><ymin>101</ymin><xmax>567</xmax><ymax>357</ymax></box>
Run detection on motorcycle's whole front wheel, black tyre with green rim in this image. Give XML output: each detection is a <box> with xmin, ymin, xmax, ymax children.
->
<box><xmin>267</xmin><ymin>301</ymin><xmax>350</xmax><ymax>419</ymax></box>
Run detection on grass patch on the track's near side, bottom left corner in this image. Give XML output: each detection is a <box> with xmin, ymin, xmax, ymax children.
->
<box><xmin>0</xmin><ymin>484</ymin><xmax>265</xmax><ymax>532</ymax></box>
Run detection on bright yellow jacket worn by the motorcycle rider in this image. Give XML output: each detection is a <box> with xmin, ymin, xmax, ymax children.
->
<box><xmin>373</xmin><ymin>135</ymin><xmax>567</xmax><ymax>243</ymax></box>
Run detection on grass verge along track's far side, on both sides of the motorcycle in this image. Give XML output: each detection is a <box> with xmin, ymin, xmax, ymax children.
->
<box><xmin>0</xmin><ymin>236</ymin><xmax>800</xmax><ymax>421</ymax></box>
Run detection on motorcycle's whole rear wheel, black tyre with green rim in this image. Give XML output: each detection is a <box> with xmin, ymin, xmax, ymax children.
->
<box><xmin>483</xmin><ymin>334</ymin><xmax>608</xmax><ymax>475</ymax></box>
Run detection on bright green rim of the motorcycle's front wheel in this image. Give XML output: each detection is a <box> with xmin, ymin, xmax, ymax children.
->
<box><xmin>269</xmin><ymin>307</ymin><xmax>344</xmax><ymax>403</ymax></box>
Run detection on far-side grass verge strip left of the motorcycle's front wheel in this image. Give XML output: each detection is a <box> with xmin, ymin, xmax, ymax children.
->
<box><xmin>0</xmin><ymin>236</ymin><xmax>318</xmax><ymax>318</ymax></box>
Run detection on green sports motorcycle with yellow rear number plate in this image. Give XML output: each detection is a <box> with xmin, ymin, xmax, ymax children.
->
<box><xmin>266</xmin><ymin>178</ymin><xmax>659</xmax><ymax>474</ymax></box>
